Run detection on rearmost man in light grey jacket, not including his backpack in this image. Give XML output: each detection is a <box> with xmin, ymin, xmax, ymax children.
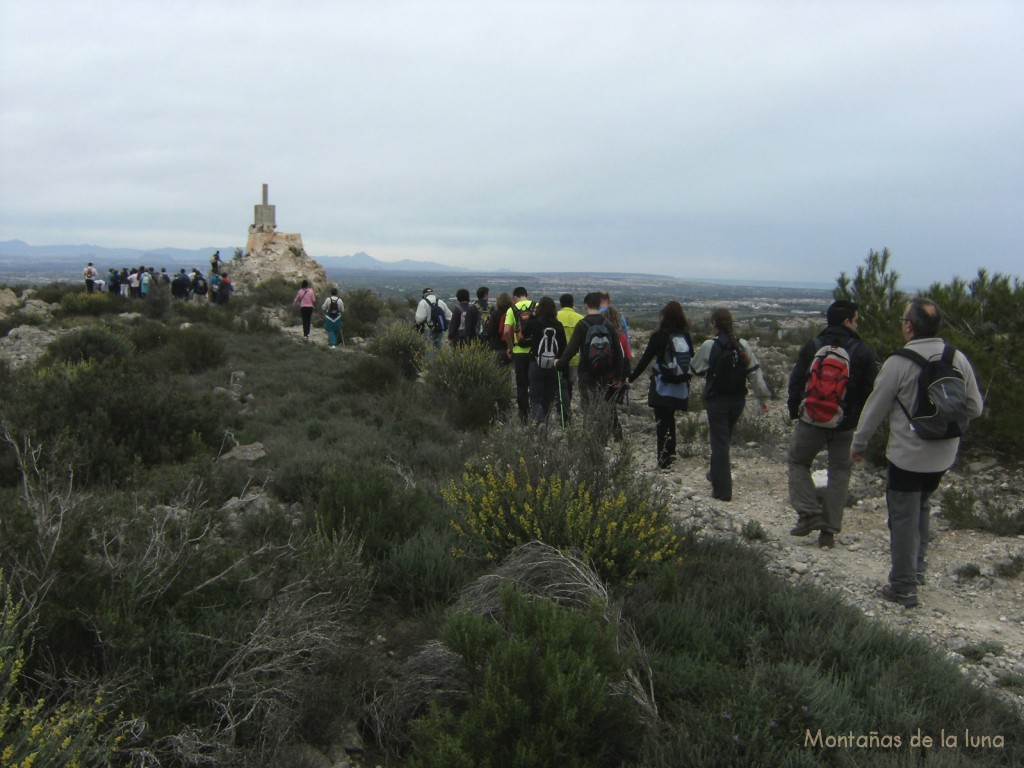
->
<box><xmin>851</xmin><ymin>298</ymin><xmax>983</xmax><ymax>608</ymax></box>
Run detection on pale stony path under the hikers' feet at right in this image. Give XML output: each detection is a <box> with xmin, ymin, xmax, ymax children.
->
<box><xmin>626</xmin><ymin>404</ymin><xmax>1024</xmax><ymax>713</ymax></box>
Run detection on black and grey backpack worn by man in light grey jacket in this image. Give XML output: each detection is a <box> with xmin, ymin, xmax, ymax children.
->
<box><xmin>893</xmin><ymin>344</ymin><xmax>971</xmax><ymax>440</ymax></box>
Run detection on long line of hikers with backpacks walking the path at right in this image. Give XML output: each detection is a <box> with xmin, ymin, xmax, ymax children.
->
<box><xmin>407</xmin><ymin>286</ymin><xmax>983</xmax><ymax>607</ymax></box>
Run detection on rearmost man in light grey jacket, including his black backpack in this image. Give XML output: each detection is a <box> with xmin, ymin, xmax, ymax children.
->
<box><xmin>851</xmin><ymin>297</ymin><xmax>984</xmax><ymax>608</ymax></box>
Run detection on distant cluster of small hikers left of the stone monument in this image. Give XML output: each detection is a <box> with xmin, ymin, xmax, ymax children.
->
<box><xmin>82</xmin><ymin>251</ymin><xmax>234</xmax><ymax>304</ymax></box>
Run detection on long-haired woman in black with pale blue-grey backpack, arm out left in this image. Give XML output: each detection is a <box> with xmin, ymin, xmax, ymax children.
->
<box><xmin>628</xmin><ymin>301</ymin><xmax>693</xmax><ymax>469</ymax></box>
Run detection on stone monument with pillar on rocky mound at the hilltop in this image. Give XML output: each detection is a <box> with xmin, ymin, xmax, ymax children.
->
<box><xmin>231</xmin><ymin>184</ymin><xmax>328</xmax><ymax>294</ymax></box>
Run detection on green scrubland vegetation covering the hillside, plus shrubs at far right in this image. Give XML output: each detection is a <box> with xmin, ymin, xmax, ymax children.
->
<box><xmin>0</xmin><ymin>253</ymin><xmax>1024</xmax><ymax>768</ymax></box>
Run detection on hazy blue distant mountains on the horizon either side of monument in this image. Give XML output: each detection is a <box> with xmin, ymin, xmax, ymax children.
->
<box><xmin>0</xmin><ymin>240</ymin><xmax>469</xmax><ymax>274</ymax></box>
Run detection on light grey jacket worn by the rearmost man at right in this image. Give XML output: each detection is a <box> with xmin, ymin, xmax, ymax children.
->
<box><xmin>851</xmin><ymin>338</ymin><xmax>984</xmax><ymax>472</ymax></box>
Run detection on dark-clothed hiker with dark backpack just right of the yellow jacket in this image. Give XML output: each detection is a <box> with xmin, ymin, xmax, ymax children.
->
<box><xmin>558</xmin><ymin>292</ymin><xmax>623</xmax><ymax>440</ymax></box>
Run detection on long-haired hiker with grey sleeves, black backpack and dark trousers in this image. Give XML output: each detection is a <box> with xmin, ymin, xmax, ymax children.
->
<box><xmin>690</xmin><ymin>307</ymin><xmax>771</xmax><ymax>502</ymax></box>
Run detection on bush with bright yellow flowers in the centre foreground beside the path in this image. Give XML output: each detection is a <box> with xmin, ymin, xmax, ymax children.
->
<box><xmin>443</xmin><ymin>458</ymin><xmax>679</xmax><ymax>583</ymax></box>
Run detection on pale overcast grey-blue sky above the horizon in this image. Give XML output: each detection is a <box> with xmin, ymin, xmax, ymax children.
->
<box><xmin>0</xmin><ymin>0</ymin><xmax>1024</xmax><ymax>286</ymax></box>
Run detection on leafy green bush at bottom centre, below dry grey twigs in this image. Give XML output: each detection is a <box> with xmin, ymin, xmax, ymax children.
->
<box><xmin>409</xmin><ymin>589</ymin><xmax>643</xmax><ymax>768</ymax></box>
